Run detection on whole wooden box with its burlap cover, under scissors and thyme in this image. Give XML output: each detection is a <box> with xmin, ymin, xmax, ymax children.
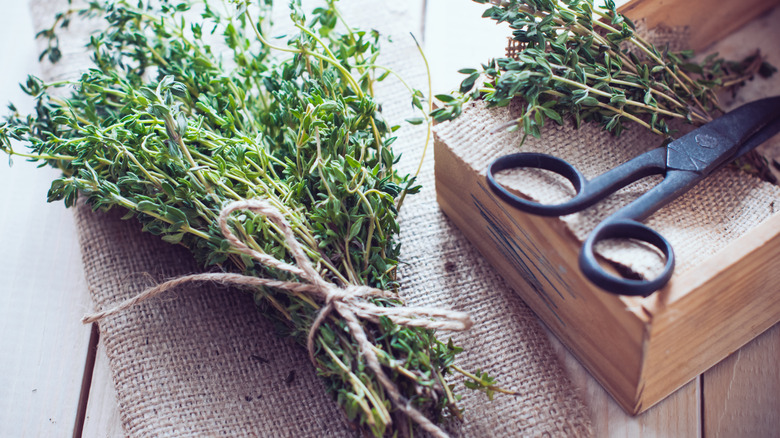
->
<box><xmin>435</xmin><ymin>0</ymin><xmax>780</xmax><ymax>414</ymax></box>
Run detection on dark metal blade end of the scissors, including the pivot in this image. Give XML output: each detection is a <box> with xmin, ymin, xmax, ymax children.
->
<box><xmin>666</xmin><ymin>96</ymin><xmax>780</xmax><ymax>175</ymax></box>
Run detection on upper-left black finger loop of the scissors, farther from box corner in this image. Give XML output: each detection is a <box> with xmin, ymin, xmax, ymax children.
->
<box><xmin>487</xmin><ymin>152</ymin><xmax>587</xmax><ymax>216</ymax></box>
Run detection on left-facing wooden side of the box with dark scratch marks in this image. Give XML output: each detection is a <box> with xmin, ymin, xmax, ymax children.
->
<box><xmin>434</xmin><ymin>136</ymin><xmax>648</xmax><ymax>412</ymax></box>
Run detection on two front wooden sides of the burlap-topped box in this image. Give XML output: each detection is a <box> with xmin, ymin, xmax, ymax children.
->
<box><xmin>434</xmin><ymin>1</ymin><xmax>780</xmax><ymax>414</ymax></box>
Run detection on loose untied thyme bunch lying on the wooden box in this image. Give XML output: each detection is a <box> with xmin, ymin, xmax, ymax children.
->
<box><xmin>432</xmin><ymin>0</ymin><xmax>774</xmax><ymax>138</ymax></box>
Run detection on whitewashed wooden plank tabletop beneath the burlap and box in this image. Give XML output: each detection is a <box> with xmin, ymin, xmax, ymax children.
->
<box><xmin>0</xmin><ymin>0</ymin><xmax>780</xmax><ymax>437</ymax></box>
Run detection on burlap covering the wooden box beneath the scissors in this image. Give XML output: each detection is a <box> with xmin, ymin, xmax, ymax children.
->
<box><xmin>435</xmin><ymin>101</ymin><xmax>780</xmax><ymax>278</ymax></box>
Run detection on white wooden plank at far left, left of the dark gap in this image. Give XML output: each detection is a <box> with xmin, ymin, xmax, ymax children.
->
<box><xmin>0</xmin><ymin>1</ymin><xmax>90</xmax><ymax>436</ymax></box>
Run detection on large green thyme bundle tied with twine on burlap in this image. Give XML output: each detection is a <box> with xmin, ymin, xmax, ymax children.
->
<box><xmin>0</xmin><ymin>0</ymin><xmax>496</xmax><ymax>436</ymax></box>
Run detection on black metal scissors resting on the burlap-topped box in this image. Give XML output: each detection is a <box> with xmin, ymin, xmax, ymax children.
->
<box><xmin>487</xmin><ymin>96</ymin><xmax>780</xmax><ymax>296</ymax></box>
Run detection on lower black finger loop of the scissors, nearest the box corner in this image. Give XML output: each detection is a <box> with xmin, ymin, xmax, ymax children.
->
<box><xmin>579</xmin><ymin>219</ymin><xmax>674</xmax><ymax>297</ymax></box>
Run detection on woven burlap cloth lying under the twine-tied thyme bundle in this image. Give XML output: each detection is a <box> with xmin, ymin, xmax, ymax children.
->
<box><xmin>33</xmin><ymin>0</ymin><xmax>591</xmax><ymax>437</ymax></box>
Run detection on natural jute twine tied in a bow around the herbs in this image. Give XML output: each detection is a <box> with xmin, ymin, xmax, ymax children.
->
<box><xmin>82</xmin><ymin>199</ymin><xmax>472</xmax><ymax>437</ymax></box>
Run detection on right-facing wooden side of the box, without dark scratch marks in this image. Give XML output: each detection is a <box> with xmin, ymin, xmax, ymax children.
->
<box><xmin>641</xmin><ymin>214</ymin><xmax>780</xmax><ymax>410</ymax></box>
